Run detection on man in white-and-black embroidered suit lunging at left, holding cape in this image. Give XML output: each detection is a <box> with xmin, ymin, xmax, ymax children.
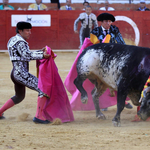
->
<box><xmin>0</xmin><ymin>22</ymin><xmax>50</xmax><ymax>124</ymax></box>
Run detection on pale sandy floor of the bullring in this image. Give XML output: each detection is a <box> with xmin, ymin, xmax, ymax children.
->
<box><xmin>0</xmin><ymin>53</ymin><xmax>150</xmax><ymax>150</ymax></box>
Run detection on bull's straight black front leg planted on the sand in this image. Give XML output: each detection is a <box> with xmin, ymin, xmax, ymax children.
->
<box><xmin>112</xmin><ymin>85</ymin><xmax>127</xmax><ymax>127</ymax></box>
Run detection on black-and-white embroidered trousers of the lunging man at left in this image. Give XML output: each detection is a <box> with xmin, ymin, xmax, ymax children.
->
<box><xmin>11</xmin><ymin>61</ymin><xmax>44</xmax><ymax>104</ymax></box>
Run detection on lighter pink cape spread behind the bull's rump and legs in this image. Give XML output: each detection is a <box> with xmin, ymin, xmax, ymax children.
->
<box><xmin>64</xmin><ymin>38</ymin><xmax>128</xmax><ymax>110</ymax></box>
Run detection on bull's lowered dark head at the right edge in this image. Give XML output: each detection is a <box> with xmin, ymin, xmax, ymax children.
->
<box><xmin>137</xmin><ymin>92</ymin><xmax>150</xmax><ymax>121</ymax></box>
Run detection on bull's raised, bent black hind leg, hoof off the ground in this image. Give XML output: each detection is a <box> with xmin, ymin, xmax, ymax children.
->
<box><xmin>74</xmin><ymin>75</ymin><xmax>88</xmax><ymax>104</ymax></box>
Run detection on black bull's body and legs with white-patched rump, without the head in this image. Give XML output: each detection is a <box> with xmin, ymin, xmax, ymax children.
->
<box><xmin>74</xmin><ymin>43</ymin><xmax>150</xmax><ymax>126</ymax></box>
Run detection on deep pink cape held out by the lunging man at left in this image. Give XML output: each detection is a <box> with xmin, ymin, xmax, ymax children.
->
<box><xmin>37</xmin><ymin>47</ymin><xmax>74</xmax><ymax>122</ymax></box>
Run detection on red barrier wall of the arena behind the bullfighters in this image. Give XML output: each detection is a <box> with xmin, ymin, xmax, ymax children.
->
<box><xmin>0</xmin><ymin>10</ymin><xmax>150</xmax><ymax>50</ymax></box>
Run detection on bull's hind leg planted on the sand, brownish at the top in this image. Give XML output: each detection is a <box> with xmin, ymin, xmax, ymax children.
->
<box><xmin>90</xmin><ymin>79</ymin><xmax>107</xmax><ymax>120</ymax></box>
